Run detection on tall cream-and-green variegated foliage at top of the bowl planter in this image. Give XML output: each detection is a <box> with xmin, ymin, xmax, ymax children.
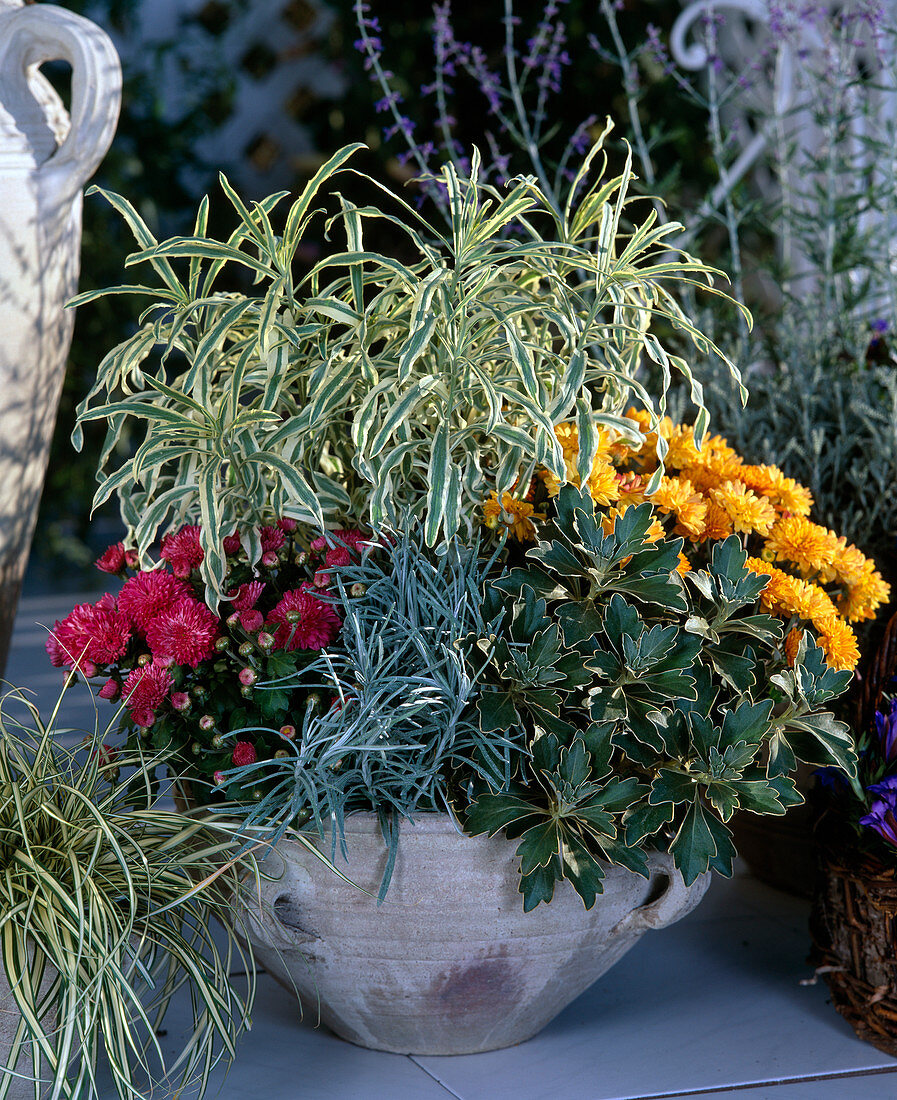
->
<box><xmin>74</xmin><ymin>130</ymin><xmax>736</xmax><ymax>603</ymax></box>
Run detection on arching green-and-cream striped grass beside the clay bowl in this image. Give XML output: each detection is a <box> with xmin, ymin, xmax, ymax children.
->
<box><xmin>0</xmin><ymin>691</ymin><xmax>254</xmax><ymax>1100</ymax></box>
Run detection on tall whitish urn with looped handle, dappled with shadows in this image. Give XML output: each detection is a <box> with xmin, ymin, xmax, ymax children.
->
<box><xmin>0</xmin><ymin>0</ymin><xmax>121</xmax><ymax>673</ymax></box>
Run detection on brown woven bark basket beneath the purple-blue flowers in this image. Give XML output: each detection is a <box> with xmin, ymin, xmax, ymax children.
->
<box><xmin>810</xmin><ymin>849</ymin><xmax>897</xmax><ymax>1057</ymax></box>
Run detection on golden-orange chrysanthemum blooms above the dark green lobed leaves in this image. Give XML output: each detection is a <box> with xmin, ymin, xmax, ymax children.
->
<box><xmin>484</xmin><ymin>409</ymin><xmax>889</xmax><ymax>669</ymax></box>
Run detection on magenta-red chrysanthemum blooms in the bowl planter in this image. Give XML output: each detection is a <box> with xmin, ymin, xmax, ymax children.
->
<box><xmin>46</xmin><ymin>518</ymin><xmax>365</xmax><ymax>743</ymax></box>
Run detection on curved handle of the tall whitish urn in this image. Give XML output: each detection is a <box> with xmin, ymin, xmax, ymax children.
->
<box><xmin>0</xmin><ymin>4</ymin><xmax>121</xmax><ymax>201</ymax></box>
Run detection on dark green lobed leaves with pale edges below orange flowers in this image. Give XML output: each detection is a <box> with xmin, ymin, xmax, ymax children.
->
<box><xmin>467</xmin><ymin>485</ymin><xmax>856</xmax><ymax>909</ymax></box>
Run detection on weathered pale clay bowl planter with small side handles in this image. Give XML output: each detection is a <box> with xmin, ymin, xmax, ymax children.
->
<box><xmin>236</xmin><ymin>814</ymin><xmax>709</xmax><ymax>1054</ymax></box>
